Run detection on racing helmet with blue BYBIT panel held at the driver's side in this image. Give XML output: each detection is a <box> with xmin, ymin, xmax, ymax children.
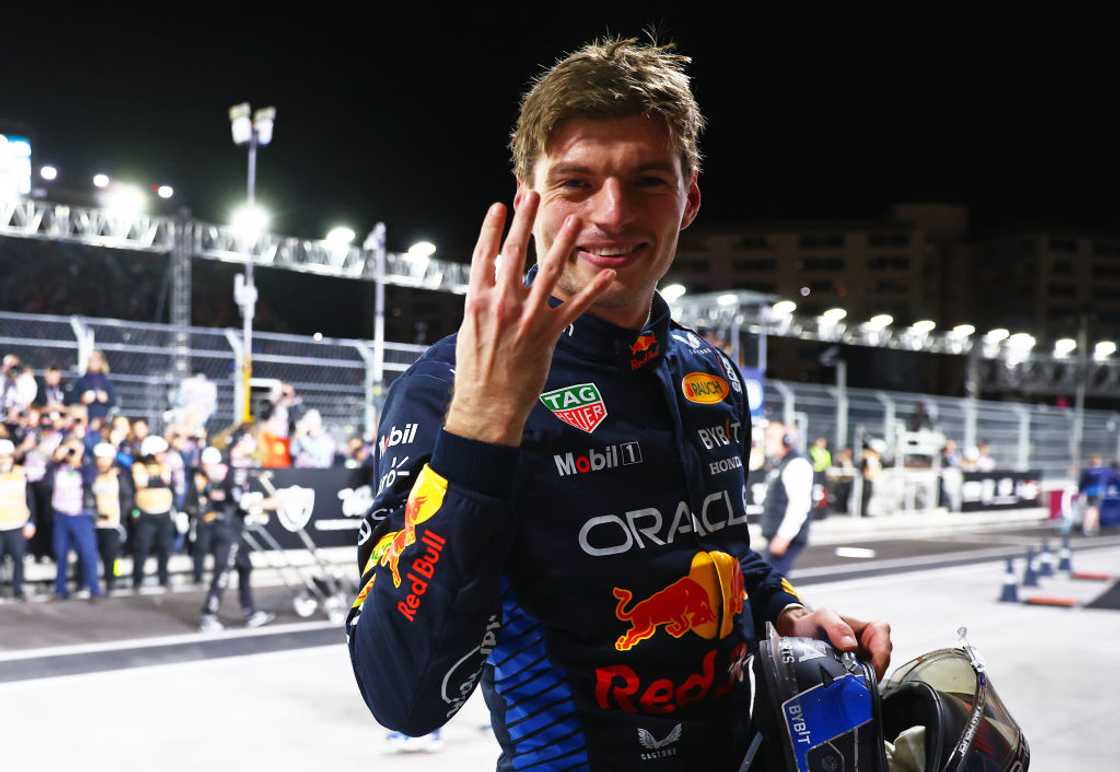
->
<box><xmin>743</xmin><ymin>624</ymin><xmax>1030</xmax><ymax>772</ymax></box>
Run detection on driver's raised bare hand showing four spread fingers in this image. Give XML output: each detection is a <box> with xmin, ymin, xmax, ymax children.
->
<box><xmin>445</xmin><ymin>192</ymin><xmax>615</xmax><ymax>446</ymax></box>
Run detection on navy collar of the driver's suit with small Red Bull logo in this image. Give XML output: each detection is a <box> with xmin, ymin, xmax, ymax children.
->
<box><xmin>525</xmin><ymin>266</ymin><xmax>672</xmax><ymax>372</ymax></box>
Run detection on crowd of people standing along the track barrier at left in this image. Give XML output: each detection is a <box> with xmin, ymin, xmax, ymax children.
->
<box><xmin>0</xmin><ymin>352</ymin><xmax>372</xmax><ymax>609</ymax></box>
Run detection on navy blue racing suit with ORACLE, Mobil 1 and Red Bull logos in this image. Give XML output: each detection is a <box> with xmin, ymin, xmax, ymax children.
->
<box><xmin>346</xmin><ymin>296</ymin><xmax>799</xmax><ymax>770</ymax></box>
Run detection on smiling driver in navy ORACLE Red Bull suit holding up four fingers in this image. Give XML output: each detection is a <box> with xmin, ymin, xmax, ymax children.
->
<box><xmin>347</xmin><ymin>40</ymin><xmax>889</xmax><ymax>769</ymax></box>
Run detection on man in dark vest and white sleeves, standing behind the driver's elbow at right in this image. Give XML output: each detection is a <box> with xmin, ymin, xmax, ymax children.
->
<box><xmin>762</xmin><ymin>421</ymin><xmax>813</xmax><ymax>576</ymax></box>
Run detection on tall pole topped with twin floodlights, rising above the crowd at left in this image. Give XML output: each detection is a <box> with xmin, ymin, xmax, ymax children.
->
<box><xmin>230</xmin><ymin>102</ymin><xmax>277</xmax><ymax>421</ymax></box>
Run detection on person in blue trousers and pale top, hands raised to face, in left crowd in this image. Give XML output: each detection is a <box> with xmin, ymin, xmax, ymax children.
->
<box><xmin>48</xmin><ymin>437</ymin><xmax>101</xmax><ymax>601</ymax></box>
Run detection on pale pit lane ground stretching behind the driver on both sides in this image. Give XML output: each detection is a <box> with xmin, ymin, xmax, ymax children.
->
<box><xmin>0</xmin><ymin>519</ymin><xmax>1120</xmax><ymax>772</ymax></box>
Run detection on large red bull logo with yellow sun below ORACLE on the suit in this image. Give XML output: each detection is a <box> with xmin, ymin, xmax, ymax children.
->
<box><xmin>614</xmin><ymin>552</ymin><xmax>744</xmax><ymax>651</ymax></box>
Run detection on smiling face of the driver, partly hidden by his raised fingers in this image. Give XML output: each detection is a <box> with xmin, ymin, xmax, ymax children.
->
<box><xmin>515</xmin><ymin>115</ymin><xmax>700</xmax><ymax>327</ymax></box>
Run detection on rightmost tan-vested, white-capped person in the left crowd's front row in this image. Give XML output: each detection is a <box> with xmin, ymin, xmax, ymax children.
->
<box><xmin>132</xmin><ymin>435</ymin><xmax>174</xmax><ymax>589</ymax></box>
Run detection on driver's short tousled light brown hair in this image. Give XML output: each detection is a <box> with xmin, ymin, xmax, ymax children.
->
<box><xmin>510</xmin><ymin>34</ymin><xmax>704</xmax><ymax>185</ymax></box>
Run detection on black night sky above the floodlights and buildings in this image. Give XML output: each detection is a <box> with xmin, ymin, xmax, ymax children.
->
<box><xmin>0</xmin><ymin>3</ymin><xmax>1118</xmax><ymax>259</ymax></box>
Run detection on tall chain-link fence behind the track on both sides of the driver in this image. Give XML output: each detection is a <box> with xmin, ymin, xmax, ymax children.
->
<box><xmin>0</xmin><ymin>313</ymin><xmax>1120</xmax><ymax>478</ymax></box>
